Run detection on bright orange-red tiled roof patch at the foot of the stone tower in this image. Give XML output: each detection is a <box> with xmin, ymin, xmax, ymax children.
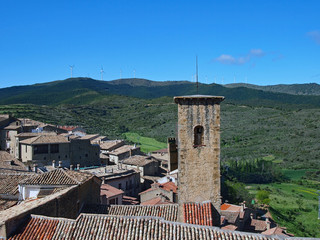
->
<box><xmin>183</xmin><ymin>202</ymin><xmax>213</xmax><ymax>226</ymax></box>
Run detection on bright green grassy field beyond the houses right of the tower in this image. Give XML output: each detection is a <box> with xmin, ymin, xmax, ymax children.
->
<box><xmin>248</xmin><ymin>169</ymin><xmax>320</xmax><ymax>237</ymax></box>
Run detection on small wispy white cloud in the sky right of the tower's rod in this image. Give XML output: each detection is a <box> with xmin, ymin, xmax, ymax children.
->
<box><xmin>214</xmin><ymin>49</ymin><xmax>265</xmax><ymax>65</ymax></box>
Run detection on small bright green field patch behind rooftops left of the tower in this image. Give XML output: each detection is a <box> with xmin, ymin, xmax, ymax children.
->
<box><xmin>124</xmin><ymin>132</ymin><xmax>167</xmax><ymax>153</ymax></box>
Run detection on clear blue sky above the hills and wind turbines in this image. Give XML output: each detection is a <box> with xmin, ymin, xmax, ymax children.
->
<box><xmin>0</xmin><ymin>0</ymin><xmax>320</xmax><ymax>88</ymax></box>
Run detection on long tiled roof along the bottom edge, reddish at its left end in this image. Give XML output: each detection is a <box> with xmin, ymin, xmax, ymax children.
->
<box><xmin>9</xmin><ymin>214</ymin><xmax>279</xmax><ymax>240</ymax></box>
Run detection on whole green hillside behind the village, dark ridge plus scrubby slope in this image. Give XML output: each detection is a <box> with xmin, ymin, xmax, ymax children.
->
<box><xmin>0</xmin><ymin>78</ymin><xmax>320</xmax><ymax>172</ymax></box>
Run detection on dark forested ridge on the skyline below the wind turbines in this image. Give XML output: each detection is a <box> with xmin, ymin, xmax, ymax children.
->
<box><xmin>0</xmin><ymin>78</ymin><xmax>320</xmax><ymax>108</ymax></box>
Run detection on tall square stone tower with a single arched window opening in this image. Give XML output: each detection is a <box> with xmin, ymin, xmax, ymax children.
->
<box><xmin>174</xmin><ymin>95</ymin><xmax>224</xmax><ymax>224</ymax></box>
